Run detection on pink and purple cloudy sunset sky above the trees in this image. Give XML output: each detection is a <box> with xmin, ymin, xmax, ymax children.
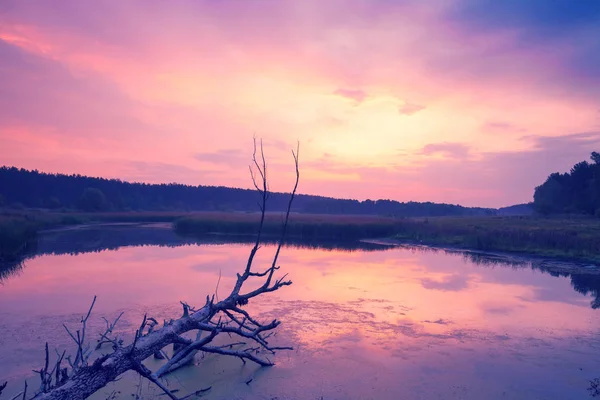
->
<box><xmin>0</xmin><ymin>0</ymin><xmax>600</xmax><ymax>207</ymax></box>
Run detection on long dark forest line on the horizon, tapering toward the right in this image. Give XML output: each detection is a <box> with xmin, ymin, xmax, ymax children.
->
<box><xmin>0</xmin><ymin>167</ymin><xmax>495</xmax><ymax>217</ymax></box>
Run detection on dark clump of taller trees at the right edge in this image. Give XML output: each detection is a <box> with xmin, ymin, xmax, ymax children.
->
<box><xmin>533</xmin><ymin>152</ymin><xmax>600</xmax><ymax>217</ymax></box>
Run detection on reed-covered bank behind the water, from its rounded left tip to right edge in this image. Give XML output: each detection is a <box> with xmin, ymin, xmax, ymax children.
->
<box><xmin>174</xmin><ymin>213</ymin><xmax>600</xmax><ymax>262</ymax></box>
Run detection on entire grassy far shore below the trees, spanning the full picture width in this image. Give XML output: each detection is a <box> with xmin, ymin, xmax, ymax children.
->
<box><xmin>0</xmin><ymin>210</ymin><xmax>600</xmax><ymax>264</ymax></box>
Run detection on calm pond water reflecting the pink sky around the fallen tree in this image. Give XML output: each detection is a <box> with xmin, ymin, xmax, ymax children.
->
<box><xmin>0</xmin><ymin>227</ymin><xmax>600</xmax><ymax>400</ymax></box>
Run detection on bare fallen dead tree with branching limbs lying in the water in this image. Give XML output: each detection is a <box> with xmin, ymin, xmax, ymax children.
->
<box><xmin>0</xmin><ymin>140</ymin><xmax>300</xmax><ymax>400</ymax></box>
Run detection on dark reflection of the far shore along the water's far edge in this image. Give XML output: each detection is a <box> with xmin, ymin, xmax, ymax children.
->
<box><xmin>8</xmin><ymin>224</ymin><xmax>600</xmax><ymax>309</ymax></box>
